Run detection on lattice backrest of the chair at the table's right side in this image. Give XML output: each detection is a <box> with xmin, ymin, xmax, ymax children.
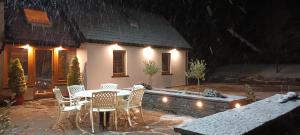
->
<box><xmin>127</xmin><ymin>88</ymin><xmax>145</xmax><ymax>107</ymax></box>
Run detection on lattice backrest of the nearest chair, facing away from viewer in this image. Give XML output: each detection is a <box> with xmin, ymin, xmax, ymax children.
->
<box><xmin>91</xmin><ymin>91</ymin><xmax>117</xmax><ymax>109</ymax></box>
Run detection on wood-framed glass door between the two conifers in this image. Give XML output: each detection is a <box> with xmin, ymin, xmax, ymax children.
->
<box><xmin>35</xmin><ymin>49</ymin><xmax>53</xmax><ymax>97</ymax></box>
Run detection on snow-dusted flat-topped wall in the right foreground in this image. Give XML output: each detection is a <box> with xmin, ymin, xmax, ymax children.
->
<box><xmin>174</xmin><ymin>94</ymin><xmax>300</xmax><ymax>135</ymax></box>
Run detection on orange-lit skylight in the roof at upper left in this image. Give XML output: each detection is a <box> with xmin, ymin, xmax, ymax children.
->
<box><xmin>24</xmin><ymin>8</ymin><xmax>51</xmax><ymax>26</ymax></box>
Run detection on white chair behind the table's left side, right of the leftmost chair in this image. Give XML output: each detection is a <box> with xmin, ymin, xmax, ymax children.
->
<box><xmin>67</xmin><ymin>85</ymin><xmax>89</xmax><ymax>105</ymax></box>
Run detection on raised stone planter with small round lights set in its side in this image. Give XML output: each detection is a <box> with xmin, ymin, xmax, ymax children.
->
<box><xmin>143</xmin><ymin>89</ymin><xmax>246</xmax><ymax>117</ymax></box>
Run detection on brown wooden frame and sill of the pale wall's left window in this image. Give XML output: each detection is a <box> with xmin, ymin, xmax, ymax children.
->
<box><xmin>112</xmin><ymin>50</ymin><xmax>128</xmax><ymax>78</ymax></box>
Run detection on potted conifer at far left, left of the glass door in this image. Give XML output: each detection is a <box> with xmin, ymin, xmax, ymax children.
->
<box><xmin>8</xmin><ymin>58</ymin><xmax>27</xmax><ymax>105</ymax></box>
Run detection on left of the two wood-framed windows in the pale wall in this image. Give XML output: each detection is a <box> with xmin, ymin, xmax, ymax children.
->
<box><xmin>113</xmin><ymin>50</ymin><xmax>126</xmax><ymax>77</ymax></box>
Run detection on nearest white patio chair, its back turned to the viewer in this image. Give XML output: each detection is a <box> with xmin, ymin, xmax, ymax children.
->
<box><xmin>90</xmin><ymin>91</ymin><xmax>117</xmax><ymax>133</ymax></box>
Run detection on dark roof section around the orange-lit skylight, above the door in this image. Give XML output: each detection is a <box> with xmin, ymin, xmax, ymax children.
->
<box><xmin>5</xmin><ymin>1</ymin><xmax>79</xmax><ymax>47</ymax></box>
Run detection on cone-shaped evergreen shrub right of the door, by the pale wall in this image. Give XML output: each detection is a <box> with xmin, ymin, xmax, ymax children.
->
<box><xmin>67</xmin><ymin>56</ymin><xmax>81</xmax><ymax>86</ymax></box>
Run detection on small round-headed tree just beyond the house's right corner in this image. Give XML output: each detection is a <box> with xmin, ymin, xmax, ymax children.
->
<box><xmin>185</xmin><ymin>59</ymin><xmax>206</xmax><ymax>89</ymax></box>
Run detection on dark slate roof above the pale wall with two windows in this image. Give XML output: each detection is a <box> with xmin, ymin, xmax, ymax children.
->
<box><xmin>63</xmin><ymin>0</ymin><xmax>191</xmax><ymax>48</ymax></box>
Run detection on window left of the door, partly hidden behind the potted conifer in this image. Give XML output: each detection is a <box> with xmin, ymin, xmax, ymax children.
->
<box><xmin>8</xmin><ymin>48</ymin><xmax>28</xmax><ymax>80</ymax></box>
